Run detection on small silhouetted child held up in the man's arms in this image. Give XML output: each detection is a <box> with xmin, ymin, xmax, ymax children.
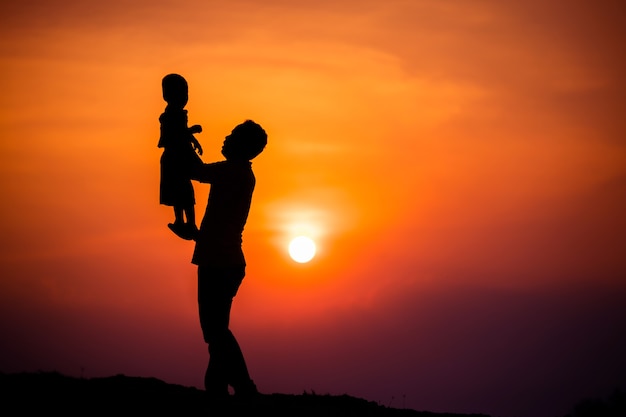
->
<box><xmin>158</xmin><ymin>74</ymin><xmax>202</xmax><ymax>240</ymax></box>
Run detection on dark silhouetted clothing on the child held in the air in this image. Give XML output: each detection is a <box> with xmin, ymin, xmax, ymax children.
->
<box><xmin>158</xmin><ymin>106</ymin><xmax>202</xmax><ymax>207</ymax></box>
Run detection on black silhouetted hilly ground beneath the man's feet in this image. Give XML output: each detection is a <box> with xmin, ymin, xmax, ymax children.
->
<box><xmin>0</xmin><ymin>372</ymin><xmax>489</xmax><ymax>417</ymax></box>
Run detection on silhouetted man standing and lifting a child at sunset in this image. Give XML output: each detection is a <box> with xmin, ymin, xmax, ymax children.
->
<box><xmin>192</xmin><ymin>120</ymin><xmax>267</xmax><ymax>401</ymax></box>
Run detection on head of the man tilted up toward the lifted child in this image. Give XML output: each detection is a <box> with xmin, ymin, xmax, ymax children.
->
<box><xmin>222</xmin><ymin>120</ymin><xmax>267</xmax><ymax>161</ymax></box>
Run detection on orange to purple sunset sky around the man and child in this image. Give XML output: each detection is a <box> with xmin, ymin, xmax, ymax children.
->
<box><xmin>0</xmin><ymin>0</ymin><xmax>626</xmax><ymax>417</ymax></box>
